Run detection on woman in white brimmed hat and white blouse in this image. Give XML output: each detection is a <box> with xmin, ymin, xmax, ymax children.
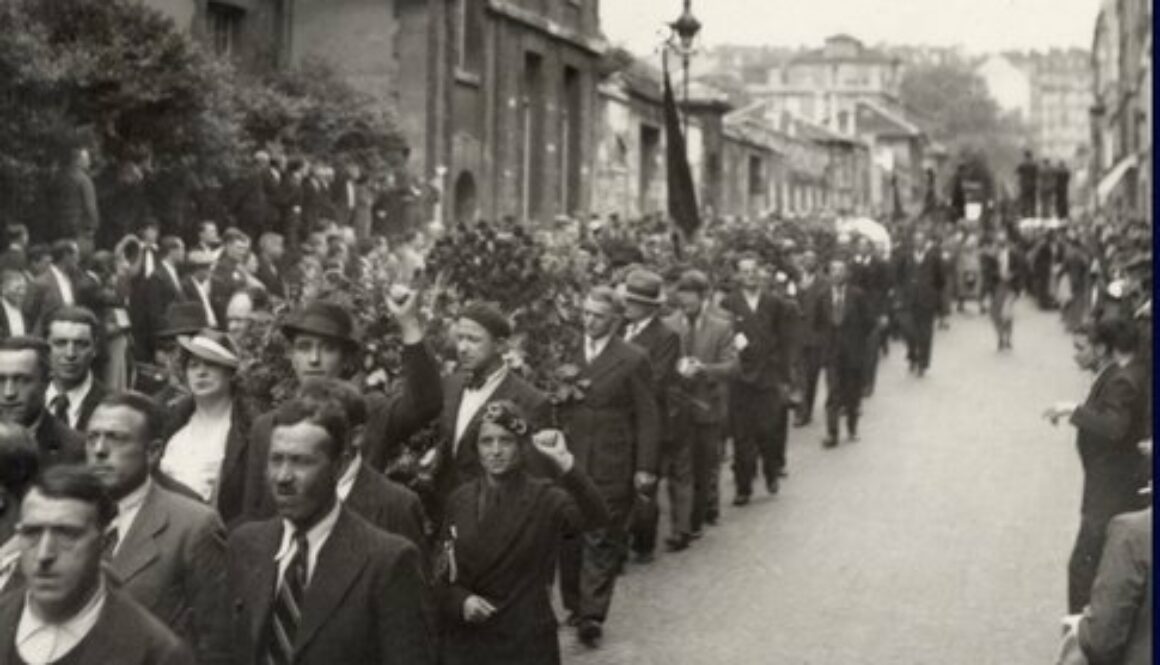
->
<box><xmin>161</xmin><ymin>328</ymin><xmax>249</xmax><ymax>523</ymax></box>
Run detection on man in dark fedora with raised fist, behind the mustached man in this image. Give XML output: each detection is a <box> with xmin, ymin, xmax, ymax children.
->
<box><xmin>244</xmin><ymin>291</ymin><xmax>443</xmax><ymax>518</ymax></box>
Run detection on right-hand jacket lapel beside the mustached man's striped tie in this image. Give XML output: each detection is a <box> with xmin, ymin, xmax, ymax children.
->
<box><xmin>295</xmin><ymin>508</ymin><xmax>367</xmax><ymax>652</ymax></box>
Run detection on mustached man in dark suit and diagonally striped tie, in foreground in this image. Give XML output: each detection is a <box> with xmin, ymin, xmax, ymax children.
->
<box><xmin>229</xmin><ymin>399</ymin><xmax>436</xmax><ymax>665</ymax></box>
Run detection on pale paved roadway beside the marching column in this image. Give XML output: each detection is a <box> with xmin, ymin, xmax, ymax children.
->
<box><xmin>561</xmin><ymin>301</ymin><xmax>1088</xmax><ymax>665</ymax></box>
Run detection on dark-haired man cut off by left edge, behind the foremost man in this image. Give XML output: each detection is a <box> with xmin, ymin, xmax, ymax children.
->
<box><xmin>0</xmin><ymin>421</ymin><xmax>39</xmax><ymax>594</ymax></box>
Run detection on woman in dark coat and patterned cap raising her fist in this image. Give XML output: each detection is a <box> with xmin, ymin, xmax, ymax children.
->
<box><xmin>435</xmin><ymin>400</ymin><xmax>608</xmax><ymax>665</ymax></box>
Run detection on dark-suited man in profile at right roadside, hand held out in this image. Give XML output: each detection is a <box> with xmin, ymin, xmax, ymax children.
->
<box><xmin>1044</xmin><ymin>318</ymin><xmax>1148</xmax><ymax>614</ymax></box>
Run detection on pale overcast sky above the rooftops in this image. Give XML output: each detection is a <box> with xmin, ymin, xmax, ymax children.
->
<box><xmin>600</xmin><ymin>0</ymin><xmax>1100</xmax><ymax>55</ymax></box>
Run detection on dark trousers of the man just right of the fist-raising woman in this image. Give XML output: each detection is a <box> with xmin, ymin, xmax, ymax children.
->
<box><xmin>560</xmin><ymin>490</ymin><xmax>632</xmax><ymax>622</ymax></box>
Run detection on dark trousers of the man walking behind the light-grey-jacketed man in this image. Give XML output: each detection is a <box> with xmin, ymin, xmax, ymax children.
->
<box><xmin>728</xmin><ymin>382</ymin><xmax>786</xmax><ymax>496</ymax></box>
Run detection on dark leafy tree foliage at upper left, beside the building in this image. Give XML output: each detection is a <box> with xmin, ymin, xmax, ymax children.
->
<box><xmin>0</xmin><ymin>0</ymin><xmax>405</xmax><ymax>224</ymax></box>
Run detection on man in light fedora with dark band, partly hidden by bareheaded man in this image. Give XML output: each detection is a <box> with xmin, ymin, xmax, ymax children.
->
<box><xmin>622</xmin><ymin>269</ymin><xmax>681</xmax><ymax>563</ymax></box>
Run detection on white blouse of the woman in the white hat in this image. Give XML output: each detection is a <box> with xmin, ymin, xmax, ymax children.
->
<box><xmin>161</xmin><ymin>404</ymin><xmax>233</xmax><ymax>503</ymax></box>
